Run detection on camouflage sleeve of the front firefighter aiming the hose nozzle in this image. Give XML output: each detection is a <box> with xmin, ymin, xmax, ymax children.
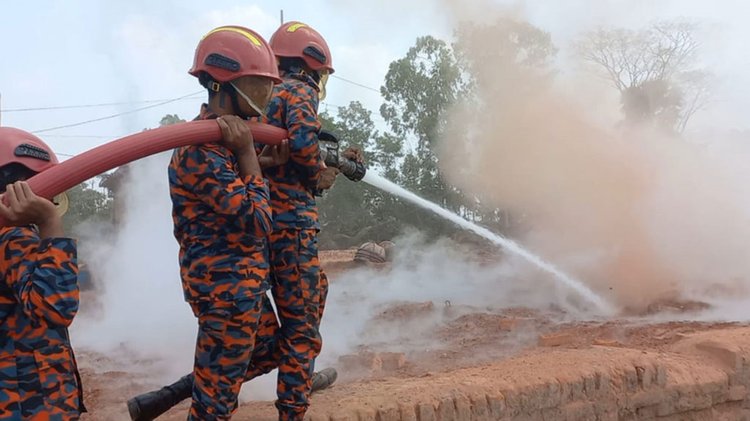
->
<box><xmin>285</xmin><ymin>84</ymin><xmax>323</xmax><ymax>189</ymax></box>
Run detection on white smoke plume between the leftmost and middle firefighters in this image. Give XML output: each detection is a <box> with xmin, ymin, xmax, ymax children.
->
<box><xmin>72</xmin><ymin>154</ymin><xmax>197</xmax><ymax>381</ymax></box>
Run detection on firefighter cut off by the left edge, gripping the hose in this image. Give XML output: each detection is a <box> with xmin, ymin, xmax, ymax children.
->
<box><xmin>0</xmin><ymin>128</ymin><xmax>85</xmax><ymax>420</ymax></box>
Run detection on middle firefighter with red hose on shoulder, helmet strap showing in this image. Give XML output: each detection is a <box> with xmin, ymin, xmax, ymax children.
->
<box><xmin>164</xmin><ymin>26</ymin><xmax>280</xmax><ymax>420</ymax></box>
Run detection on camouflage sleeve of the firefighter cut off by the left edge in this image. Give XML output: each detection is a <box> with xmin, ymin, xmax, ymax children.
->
<box><xmin>0</xmin><ymin>228</ymin><xmax>80</xmax><ymax>327</ymax></box>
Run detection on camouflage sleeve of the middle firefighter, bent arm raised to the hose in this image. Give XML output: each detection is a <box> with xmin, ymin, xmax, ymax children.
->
<box><xmin>176</xmin><ymin>146</ymin><xmax>271</xmax><ymax>236</ymax></box>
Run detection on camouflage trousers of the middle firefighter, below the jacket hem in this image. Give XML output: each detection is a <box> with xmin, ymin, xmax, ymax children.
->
<box><xmin>188</xmin><ymin>294</ymin><xmax>267</xmax><ymax>421</ymax></box>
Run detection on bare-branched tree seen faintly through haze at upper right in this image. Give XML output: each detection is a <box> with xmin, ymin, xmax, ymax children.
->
<box><xmin>577</xmin><ymin>21</ymin><xmax>709</xmax><ymax>132</ymax></box>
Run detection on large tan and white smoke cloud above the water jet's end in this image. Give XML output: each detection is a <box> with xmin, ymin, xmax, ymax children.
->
<box><xmin>432</xmin><ymin>2</ymin><xmax>750</xmax><ymax>308</ymax></box>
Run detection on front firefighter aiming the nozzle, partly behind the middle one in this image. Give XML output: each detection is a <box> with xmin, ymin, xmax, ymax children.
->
<box><xmin>256</xmin><ymin>22</ymin><xmax>344</xmax><ymax>420</ymax></box>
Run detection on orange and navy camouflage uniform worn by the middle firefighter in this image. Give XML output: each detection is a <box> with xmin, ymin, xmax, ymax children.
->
<box><xmin>169</xmin><ymin>110</ymin><xmax>271</xmax><ymax>420</ymax></box>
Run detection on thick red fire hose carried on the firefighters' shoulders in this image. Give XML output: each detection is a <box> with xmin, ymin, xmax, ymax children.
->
<box><xmin>0</xmin><ymin>120</ymin><xmax>287</xmax><ymax>226</ymax></box>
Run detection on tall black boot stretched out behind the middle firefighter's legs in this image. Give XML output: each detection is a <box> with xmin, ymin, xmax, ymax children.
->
<box><xmin>128</xmin><ymin>374</ymin><xmax>193</xmax><ymax>421</ymax></box>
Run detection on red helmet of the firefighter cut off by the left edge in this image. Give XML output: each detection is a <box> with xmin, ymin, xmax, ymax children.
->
<box><xmin>0</xmin><ymin>127</ymin><xmax>58</xmax><ymax>173</ymax></box>
